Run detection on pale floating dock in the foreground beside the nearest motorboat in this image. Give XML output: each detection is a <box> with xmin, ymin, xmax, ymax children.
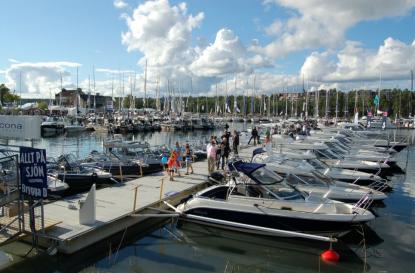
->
<box><xmin>33</xmin><ymin>158</ymin><xmax>208</xmax><ymax>254</ymax></box>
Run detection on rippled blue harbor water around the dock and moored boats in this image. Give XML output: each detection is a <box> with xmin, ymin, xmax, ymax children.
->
<box><xmin>0</xmin><ymin>124</ymin><xmax>415</xmax><ymax>273</ymax></box>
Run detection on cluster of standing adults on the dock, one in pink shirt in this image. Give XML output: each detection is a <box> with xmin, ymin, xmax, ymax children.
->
<box><xmin>206</xmin><ymin>129</ymin><xmax>239</xmax><ymax>174</ymax></box>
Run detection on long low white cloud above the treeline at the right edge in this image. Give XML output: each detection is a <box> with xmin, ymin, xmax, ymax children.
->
<box><xmin>301</xmin><ymin>37</ymin><xmax>415</xmax><ymax>82</ymax></box>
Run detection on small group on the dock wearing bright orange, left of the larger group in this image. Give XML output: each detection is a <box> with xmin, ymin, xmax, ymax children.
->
<box><xmin>162</xmin><ymin>142</ymin><xmax>194</xmax><ymax>181</ymax></box>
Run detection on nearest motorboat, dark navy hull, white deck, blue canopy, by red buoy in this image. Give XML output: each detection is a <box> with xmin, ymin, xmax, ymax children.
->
<box><xmin>177</xmin><ymin>161</ymin><xmax>375</xmax><ymax>236</ymax></box>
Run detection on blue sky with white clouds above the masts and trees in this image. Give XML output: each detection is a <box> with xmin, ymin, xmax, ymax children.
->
<box><xmin>0</xmin><ymin>0</ymin><xmax>415</xmax><ymax>98</ymax></box>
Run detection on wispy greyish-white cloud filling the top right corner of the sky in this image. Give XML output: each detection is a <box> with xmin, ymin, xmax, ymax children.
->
<box><xmin>262</xmin><ymin>0</ymin><xmax>415</xmax><ymax>58</ymax></box>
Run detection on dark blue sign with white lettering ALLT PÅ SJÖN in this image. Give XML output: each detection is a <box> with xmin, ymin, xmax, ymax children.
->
<box><xmin>20</xmin><ymin>147</ymin><xmax>48</xmax><ymax>198</ymax></box>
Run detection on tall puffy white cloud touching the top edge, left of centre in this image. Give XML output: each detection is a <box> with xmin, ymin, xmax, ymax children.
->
<box><xmin>122</xmin><ymin>0</ymin><xmax>204</xmax><ymax>65</ymax></box>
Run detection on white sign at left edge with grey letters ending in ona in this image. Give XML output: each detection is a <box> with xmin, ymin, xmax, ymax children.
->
<box><xmin>0</xmin><ymin>115</ymin><xmax>42</xmax><ymax>139</ymax></box>
